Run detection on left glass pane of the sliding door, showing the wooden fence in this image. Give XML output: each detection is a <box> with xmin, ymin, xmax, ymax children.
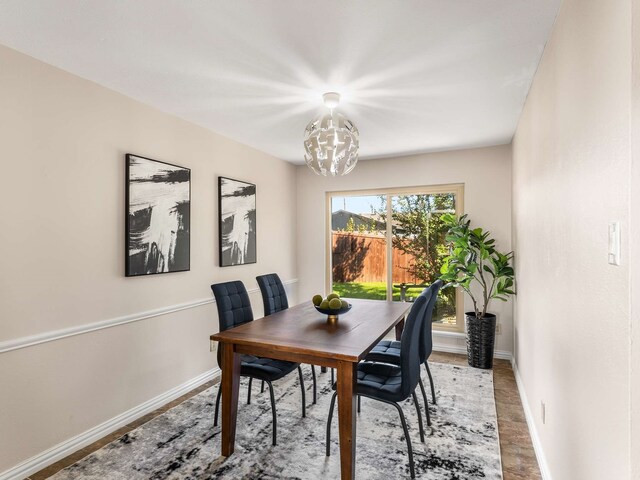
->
<box><xmin>331</xmin><ymin>195</ymin><xmax>387</xmax><ymax>300</ymax></box>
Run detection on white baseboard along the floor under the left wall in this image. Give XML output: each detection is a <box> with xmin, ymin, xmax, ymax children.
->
<box><xmin>0</xmin><ymin>367</ymin><xmax>221</xmax><ymax>480</ymax></box>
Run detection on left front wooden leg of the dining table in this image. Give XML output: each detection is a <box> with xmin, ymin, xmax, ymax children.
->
<box><xmin>220</xmin><ymin>342</ymin><xmax>240</xmax><ymax>457</ymax></box>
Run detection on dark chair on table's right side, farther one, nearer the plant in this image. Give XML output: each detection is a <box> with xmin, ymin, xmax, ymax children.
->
<box><xmin>365</xmin><ymin>280</ymin><xmax>442</xmax><ymax>425</ymax></box>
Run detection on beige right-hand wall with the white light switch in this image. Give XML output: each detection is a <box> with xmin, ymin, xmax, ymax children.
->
<box><xmin>513</xmin><ymin>0</ymin><xmax>638</xmax><ymax>480</ymax></box>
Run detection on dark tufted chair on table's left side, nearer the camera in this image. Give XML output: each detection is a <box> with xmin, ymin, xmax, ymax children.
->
<box><xmin>211</xmin><ymin>281</ymin><xmax>306</xmax><ymax>445</ymax></box>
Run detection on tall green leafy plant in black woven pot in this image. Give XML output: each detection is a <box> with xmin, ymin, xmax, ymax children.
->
<box><xmin>440</xmin><ymin>214</ymin><xmax>515</xmax><ymax>368</ymax></box>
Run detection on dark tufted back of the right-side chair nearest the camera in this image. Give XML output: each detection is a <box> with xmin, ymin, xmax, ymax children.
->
<box><xmin>400</xmin><ymin>296</ymin><xmax>427</xmax><ymax>397</ymax></box>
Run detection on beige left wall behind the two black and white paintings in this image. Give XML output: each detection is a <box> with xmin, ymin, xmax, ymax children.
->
<box><xmin>0</xmin><ymin>47</ymin><xmax>296</xmax><ymax>472</ymax></box>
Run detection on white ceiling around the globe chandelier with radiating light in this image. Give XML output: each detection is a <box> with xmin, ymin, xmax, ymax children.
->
<box><xmin>0</xmin><ymin>0</ymin><xmax>560</xmax><ymax>163</ymax></box>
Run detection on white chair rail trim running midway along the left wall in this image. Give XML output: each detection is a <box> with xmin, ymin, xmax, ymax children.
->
<box><xmin>0</xmin><ymin>278</ymin><xmax>298</xmax><ymax>354</ymax></box>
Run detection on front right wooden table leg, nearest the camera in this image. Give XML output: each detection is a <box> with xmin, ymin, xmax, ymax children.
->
<box><xmin>337</xmin><ymin>362</ymin><xmax>358</xmax><ymax>480</ymax></box>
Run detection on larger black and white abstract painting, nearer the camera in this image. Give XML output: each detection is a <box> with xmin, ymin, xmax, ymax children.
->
<box><xmin>125</xmin><ymin>154</ymin><xmax>191</xmax><ymax>277</ymax></box>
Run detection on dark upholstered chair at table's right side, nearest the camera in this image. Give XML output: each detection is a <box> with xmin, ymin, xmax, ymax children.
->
<box><xmin>326</xmin><ymin>297</ymin><xmax>427</xmax><ymax>478</ymax></box>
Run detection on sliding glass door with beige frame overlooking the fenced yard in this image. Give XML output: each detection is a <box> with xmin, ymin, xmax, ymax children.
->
<box><xmin>327</xmin><ymin>185</ymin><xmax>464</xmax><ymax>331</ymax></box>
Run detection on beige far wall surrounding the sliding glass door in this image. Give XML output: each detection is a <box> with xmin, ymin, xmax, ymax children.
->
<box><xmin>298</xmin><ymin>146</ymin><xmax>513</xmax><ymax>352</ymax></box>
